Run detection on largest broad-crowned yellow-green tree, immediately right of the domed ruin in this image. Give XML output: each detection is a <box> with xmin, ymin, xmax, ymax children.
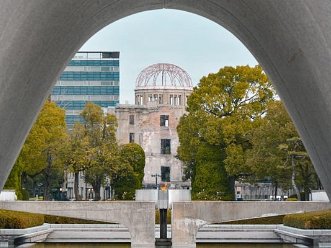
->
<box><xmin>178</xmin><ymin>66</ymin><xmax>274</xmax><ymax>198</ymax></box>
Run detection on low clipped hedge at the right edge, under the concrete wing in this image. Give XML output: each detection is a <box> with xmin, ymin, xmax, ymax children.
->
<box><xmin>284</xmin><ymin>210</ymin><xmax>331</xmax><ymax>229</ymax></box>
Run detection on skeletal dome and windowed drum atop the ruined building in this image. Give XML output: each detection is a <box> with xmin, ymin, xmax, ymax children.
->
<box><xmin>135</xmin><ymin>63</ymin><xmax>193</xmax><ymax>107</ymax></box>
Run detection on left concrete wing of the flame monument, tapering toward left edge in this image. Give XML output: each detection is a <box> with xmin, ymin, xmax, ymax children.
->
<box><xmin>0</xmin><ymin>201</ymin><xmax>155</xmax><ymax>248</ymax></box>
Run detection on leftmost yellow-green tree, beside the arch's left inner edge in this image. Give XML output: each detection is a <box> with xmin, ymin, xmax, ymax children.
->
<box><xmin>8</xmin><ymin>101</ymin><xmax>66</xmax><ymax>200</ymax></box>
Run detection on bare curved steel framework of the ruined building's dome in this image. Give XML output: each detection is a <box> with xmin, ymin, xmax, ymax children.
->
<box><xmin>136</xmin><ymin>63</ymin><xmax>192</xmax><ymax>87</ymax></box>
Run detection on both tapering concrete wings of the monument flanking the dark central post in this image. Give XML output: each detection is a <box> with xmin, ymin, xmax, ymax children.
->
<box><xmin>0</xmin><ymin>201</ymin><xmax>331</xmax><ymax>248</ymax></box>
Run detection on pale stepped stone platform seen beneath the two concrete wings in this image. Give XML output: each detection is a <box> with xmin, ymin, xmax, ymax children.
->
<box><xmin>0</xmin><ymin>224</ymin><xmax>331</xmax><ymax>247</ymax></box>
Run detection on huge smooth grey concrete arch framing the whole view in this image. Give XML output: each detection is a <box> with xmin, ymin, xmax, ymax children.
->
<box><xmin>0</xmin><ymin>0</ymin><xmax>331</xmax><ymax>199</ymax></box>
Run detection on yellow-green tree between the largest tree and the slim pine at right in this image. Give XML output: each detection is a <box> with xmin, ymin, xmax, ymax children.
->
<box><xmin>245</xmin><ymin>101</ymin><xmax>295</xmax><ymax>199</ymax></box>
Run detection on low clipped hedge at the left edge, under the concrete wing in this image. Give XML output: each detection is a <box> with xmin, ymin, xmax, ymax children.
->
<box><xmin>0</xmin><ymin>210</ymin><xmax>44</xmax><ymax>229</ymax></box>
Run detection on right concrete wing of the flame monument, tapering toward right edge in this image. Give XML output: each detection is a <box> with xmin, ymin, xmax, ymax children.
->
<box><xmin>171</xmin><ymin>201</ymin><xmax>331</xmax><ymax>248</ymax></box>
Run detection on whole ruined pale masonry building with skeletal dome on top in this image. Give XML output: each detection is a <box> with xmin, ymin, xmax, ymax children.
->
<box><xmin>109</xmin><ymin>64</ymin><xmax>192</xmax><ymax>188</ymax></box>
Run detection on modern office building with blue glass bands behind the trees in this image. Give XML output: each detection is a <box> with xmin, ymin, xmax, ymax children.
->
<box><xmin>51</xmin><ymin>52</ymin><xmax>120</xmax><ymax>128</ymax></box>
